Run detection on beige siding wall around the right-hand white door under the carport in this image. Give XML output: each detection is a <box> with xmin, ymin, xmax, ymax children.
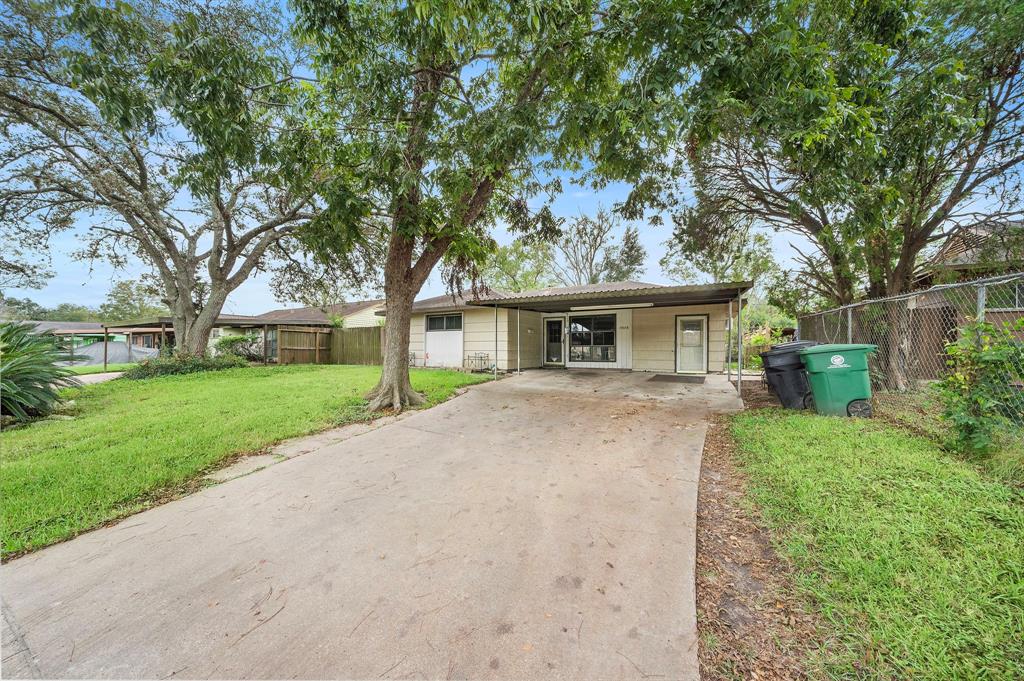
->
<box><xmin>633</xmin><ymin>304</ymin><xmax>729</xmax><ymax>373</ymax></box>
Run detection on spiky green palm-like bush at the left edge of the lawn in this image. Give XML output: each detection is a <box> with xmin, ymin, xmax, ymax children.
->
<box><xmin>0</xmin><ymin>322</ymin><xmax>80</xmax><ymax>421</ymax></box>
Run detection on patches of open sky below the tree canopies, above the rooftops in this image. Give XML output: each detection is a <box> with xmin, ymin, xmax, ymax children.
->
<box><xmin>5</xmin><ymin>174</ymin><xmax>795</xmax><ymax>314</ymax></box>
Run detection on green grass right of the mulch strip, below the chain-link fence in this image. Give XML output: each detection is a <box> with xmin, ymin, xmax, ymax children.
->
<box><xmin>731</xmin><ymin>410</ymin><xmax>1024</xmax><ymax>679</ymax></box>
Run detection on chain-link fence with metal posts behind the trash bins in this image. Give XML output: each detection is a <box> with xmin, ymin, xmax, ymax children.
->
<box><xmin>798</xmin><ymin>272</ymin><xmax>1024</xmax><ymax>428</ymax></box>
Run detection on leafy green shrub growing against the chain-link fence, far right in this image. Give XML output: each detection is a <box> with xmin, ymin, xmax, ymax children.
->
<box><xmin>937</xmin><ymin>318</ymin><xmax>1024</xmax><ymax>456</ymax></box>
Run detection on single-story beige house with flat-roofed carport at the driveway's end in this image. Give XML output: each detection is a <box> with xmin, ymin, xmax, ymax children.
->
<box><xmin>389</xmin><ymin>282</ymin><xmax>753</xmax><ymax>374</ymax></box>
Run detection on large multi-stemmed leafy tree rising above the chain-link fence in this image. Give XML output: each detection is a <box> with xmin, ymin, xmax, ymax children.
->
<box><xmin>651</xmin><ymin>0</ymin><xmax>1024</xmax><ymax>304</ymax></box>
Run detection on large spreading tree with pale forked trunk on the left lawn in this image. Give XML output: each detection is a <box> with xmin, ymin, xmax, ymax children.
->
<box><xmin>0</xmin><ymin>0</ymin><xmax>316</xmax><ymax>353</ymax></box>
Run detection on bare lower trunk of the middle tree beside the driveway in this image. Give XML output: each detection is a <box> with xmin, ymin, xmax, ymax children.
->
<box><xmin>367</xmin><ymin>263</ymin><xmax>426</xmax><ymax>412</ymax></box>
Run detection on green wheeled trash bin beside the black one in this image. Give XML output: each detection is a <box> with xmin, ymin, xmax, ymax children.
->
<box><xmin>800</xmin><ymin>343</ymin><xmax>878</xmax><ymax>418</ymax></box>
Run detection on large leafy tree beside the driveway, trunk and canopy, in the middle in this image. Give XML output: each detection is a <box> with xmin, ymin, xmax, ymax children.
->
<box><xmin>295</xmin><ymin>0</ymin><xmax>734</xmax><ymax>409</ymax></box>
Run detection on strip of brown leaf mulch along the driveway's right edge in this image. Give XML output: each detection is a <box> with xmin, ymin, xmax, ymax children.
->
<box><xmin>696</xmin><ymin>382</ymin><xmax>821</xmax><ymax>680</ymax></box>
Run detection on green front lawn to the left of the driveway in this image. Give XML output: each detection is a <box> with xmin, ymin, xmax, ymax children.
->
<box><xmin>0</xmin><ymin>366</ymin><xmax>488</xmax><ymax>556</ymax></box>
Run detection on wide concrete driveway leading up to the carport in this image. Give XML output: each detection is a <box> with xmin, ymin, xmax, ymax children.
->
<box><xmin>2</xmin><ymin>372</ymin><xmax>739</xmax><ymax>680</ymax></box>
